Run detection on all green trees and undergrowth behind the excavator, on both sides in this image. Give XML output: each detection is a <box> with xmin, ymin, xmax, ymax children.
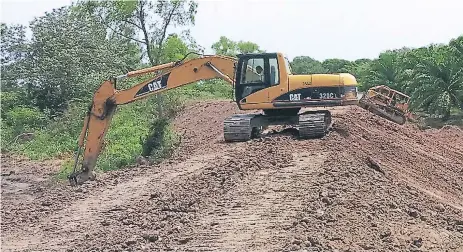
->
<box><xmin>0</xmin><ymin>0</ymin><xmax>463</xmax><ymax>170</ymax></box>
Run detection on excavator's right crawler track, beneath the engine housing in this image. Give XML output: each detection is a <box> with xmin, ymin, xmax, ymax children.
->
<box><xmin>299</xmin><ymin>113</ymin><xmax>329</xmax><ymax>139</ymax></box>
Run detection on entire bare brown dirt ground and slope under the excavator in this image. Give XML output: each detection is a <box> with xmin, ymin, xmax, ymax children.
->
<box><xmin>2</xmin><ymin>101</ymin><xmax>463</xmax><ymax>251</ymax></box>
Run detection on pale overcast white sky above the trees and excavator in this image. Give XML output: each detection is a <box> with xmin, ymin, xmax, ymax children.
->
<box><xmin>1</xmin><ymin>0</ymin><xmax>463</xmax><ymax>60</ymax></box>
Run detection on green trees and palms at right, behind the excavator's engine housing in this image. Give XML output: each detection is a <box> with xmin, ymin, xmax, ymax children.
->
<box><xmin>291</xmin><ymin>38</ymin><xmax>463</xmax><ymax>120</ymax></box>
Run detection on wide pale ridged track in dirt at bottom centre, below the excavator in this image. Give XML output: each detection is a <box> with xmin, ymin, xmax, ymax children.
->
<box><xmin>189</xmin><ymin>153</ymin><xmax>327</xmax><ymax>251</ymax></box>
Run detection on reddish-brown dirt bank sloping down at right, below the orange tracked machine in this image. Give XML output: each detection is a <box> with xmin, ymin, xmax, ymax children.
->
<box><xmin>335</xmin><ymin>105</ymin><xmax>463</xmax><ymax>211</ymax></box>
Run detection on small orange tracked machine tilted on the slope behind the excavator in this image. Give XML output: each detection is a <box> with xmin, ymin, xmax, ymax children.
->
<box><xmin>359</xmin><ymin>85</ymin><xmax>411</xmax><ymax>125</ymax></box>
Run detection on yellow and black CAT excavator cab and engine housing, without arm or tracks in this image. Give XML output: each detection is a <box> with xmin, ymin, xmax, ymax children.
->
<box><xmin>234</xmin><ymin>52</ymin><xmax>358</xmax><ymax>116</ymax></box>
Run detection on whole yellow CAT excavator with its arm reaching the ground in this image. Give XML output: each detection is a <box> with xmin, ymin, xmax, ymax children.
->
<box><xmin>68</xmin><ymin>52</ymin><xmax>358</xmax><ymax>185</ymax></box>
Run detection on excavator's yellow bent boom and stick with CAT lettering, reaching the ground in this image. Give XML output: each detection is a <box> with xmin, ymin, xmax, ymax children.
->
<box><xmin>68</xmin><ymin>55</ymin><xmax>236</xmax><ymax>185</ymax></box>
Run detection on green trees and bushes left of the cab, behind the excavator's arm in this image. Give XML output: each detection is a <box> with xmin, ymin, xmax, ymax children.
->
<box><xmin>1</xmin><ymin>0</ymin><xmax>203</xmax><ymax>169</ymax></box>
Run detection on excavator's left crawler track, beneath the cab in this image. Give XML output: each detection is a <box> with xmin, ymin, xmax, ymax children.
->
<box><xmin>223</xmin><ymin>114</ymin><xmax>255</xmax><ymax>142</ymax></box>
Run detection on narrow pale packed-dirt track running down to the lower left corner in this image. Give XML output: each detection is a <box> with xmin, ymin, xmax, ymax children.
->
<box><xmin>2</xmin><ymin>155</ymin><xmax>221</xmax><ymax>251</ymax></box>
